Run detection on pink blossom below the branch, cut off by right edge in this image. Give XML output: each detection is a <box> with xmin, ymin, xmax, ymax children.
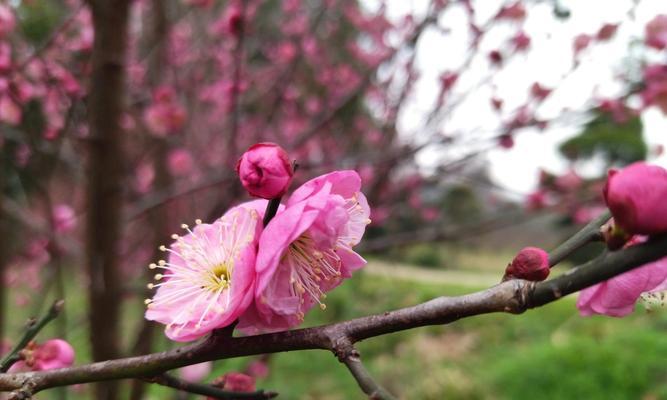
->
<box><xmin>577</xmin><ymin>237</ymin><xmax>667</xmax><ymax>317</ymax></box>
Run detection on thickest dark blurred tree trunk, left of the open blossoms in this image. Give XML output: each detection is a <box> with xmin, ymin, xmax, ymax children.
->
<box><xmin>86</xmin><ymin>0</ymin><xmax>130</xmax><ymax>400</ymax></box>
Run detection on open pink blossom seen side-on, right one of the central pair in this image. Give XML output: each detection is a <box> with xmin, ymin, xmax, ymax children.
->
<box><xmin>238</xmin><ymin>171</ymin><xmax>370</xmax><ymax>333</ymax></box>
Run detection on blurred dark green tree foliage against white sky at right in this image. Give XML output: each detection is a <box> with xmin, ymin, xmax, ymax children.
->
<box><xmin>559</xmin><ymin>113</ymin><xmax>648</xmax><ymax>166</ymax></box>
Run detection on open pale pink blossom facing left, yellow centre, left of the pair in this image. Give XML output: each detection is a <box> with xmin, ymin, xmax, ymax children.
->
<box><xmin>146</xmin><ymin>207</ymin><xmax>262</xmax><ymax>341</ymax></box>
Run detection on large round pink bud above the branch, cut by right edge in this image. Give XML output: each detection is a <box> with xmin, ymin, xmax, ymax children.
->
<box><xmin>603</xmin><ymin>162</ymin><xmax>667</xmax><ymax>235</ymax></box>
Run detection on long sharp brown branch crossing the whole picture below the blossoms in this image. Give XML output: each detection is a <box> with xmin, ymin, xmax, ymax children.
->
<box><xmin>0</xmin><ymin>235</ymin><xmax>667</xmax><ymax>393</ymax></box>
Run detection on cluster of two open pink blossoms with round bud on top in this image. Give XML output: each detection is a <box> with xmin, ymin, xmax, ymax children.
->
<box><xmin>146</xmin><ymin>148</ymin><xmax>370</xmax><ymax>341</ymax></box>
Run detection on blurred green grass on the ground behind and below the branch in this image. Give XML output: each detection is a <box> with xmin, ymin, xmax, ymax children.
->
<box><xmin>6</xmin><ymin>258</ymin><xmax>667</xmax><ymax>400</ymax></box>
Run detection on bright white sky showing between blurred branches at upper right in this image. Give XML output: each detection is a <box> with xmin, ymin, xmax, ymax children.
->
<box><xmin>367</xmin><ymin>0</ymin><xmax>667</xmax><ymax>197</ymax></box>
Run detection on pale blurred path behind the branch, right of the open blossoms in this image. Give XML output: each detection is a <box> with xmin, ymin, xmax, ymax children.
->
<box><xmin>364</xmin><ymin>260</ymin><xmax>502</xmax><ymax>288</ymax></box>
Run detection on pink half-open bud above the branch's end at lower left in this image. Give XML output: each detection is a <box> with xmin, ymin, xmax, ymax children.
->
<box><xmin>9</xmin><ymin>339</ymin><xmax>74</xmax><ymax>372</ymax></box>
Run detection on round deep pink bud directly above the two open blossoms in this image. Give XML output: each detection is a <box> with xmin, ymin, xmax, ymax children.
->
<box><xmin>236</xmin><ymin>143</ymin><xmax>294</xmax><ymax>199</ymax></box>
